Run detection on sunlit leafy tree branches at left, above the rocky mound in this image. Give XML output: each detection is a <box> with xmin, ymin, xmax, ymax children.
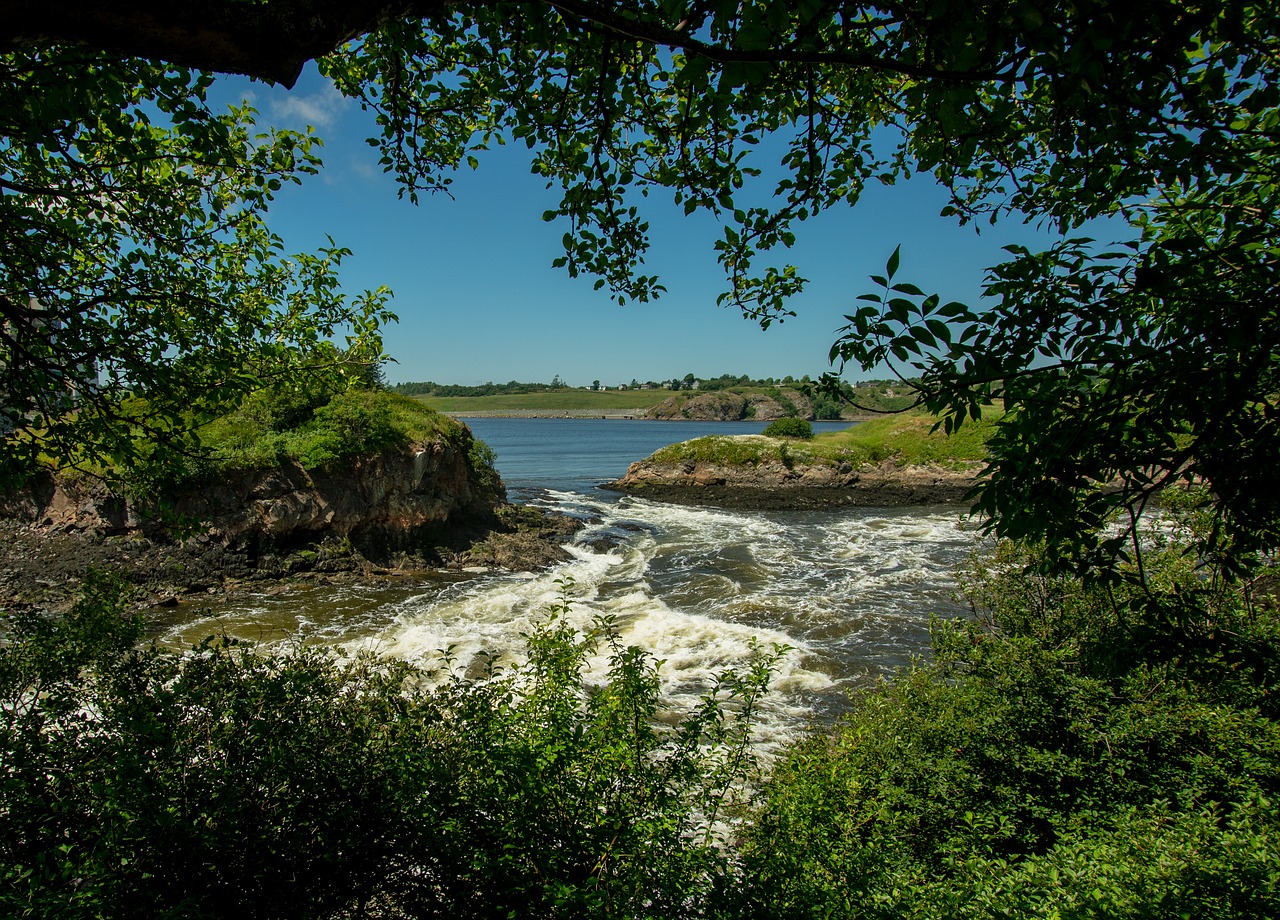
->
<box><xmin>0</xmin><ymin>47</ymin><xmax>393</xmax><ymax>486</ymax></box>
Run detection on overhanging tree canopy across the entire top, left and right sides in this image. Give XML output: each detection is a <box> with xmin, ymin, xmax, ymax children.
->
<box><xmin>0</xmin><ymin>0</ymin><xmax>1280</xmax><ymax>569</ymax></box>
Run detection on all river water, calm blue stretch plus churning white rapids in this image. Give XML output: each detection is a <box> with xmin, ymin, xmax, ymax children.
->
<box><xmin>166</xmin><ymin>418</ymin><xmax>975</xmax><ymax>743</ymax></box>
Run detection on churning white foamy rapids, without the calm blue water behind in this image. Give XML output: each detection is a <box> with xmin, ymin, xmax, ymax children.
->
<box><xmin>170</xmin><ymin>493</ymin><xmax>977</xmax><ymax>749</ymax></box>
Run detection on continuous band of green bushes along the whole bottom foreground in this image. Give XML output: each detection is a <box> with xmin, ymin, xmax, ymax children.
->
<box><xmin>0</xmin><ymin>496</ymin><xmax>1280</xmax><ymax>920</ymax></box>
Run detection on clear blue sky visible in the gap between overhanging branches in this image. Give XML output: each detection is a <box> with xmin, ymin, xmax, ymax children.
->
<box><xmin>219</xmin><ymin>72</ymin><xmax>1070</xmax><ymax>386</ymax></box>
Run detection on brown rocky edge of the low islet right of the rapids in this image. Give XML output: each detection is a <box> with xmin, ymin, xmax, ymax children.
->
<box><xmin>603</xmin><ymin>445</ymin><xmax>980</xmax><ymax>511</ymax></box>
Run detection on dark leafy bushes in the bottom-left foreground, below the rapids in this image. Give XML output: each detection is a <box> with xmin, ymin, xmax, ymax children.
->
<box><xmin>0</xmin><ymin>581</ymin><xmax>772</xmax><ymax>919</ymax></box>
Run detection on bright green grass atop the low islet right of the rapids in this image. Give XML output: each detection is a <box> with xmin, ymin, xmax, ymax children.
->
<box><xmin>652</xmin><ymin>409</ymin><xmax>1002</xmax><ymax>468</ymax></box>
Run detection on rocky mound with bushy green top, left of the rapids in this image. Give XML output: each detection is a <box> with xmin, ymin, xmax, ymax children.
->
<box><xmin>0</xmin><ymin>386</ymin><xmax>581</xmax><ymax>609</ymax></box>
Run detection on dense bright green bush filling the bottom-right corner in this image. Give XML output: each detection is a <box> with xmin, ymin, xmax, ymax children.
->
<box><xmin>739</xmin><ymin>524</ymin><xmax>1280</xmax><ymax>919</ymax></box>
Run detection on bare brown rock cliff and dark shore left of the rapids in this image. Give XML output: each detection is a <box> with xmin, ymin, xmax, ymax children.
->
<box><xmin>0</xmin><ymin>441</ymin><xmax>581</xmax><ymax>608</ymax></box>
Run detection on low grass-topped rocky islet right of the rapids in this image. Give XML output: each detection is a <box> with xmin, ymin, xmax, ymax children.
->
<box><xmin>604</xmin><ymin>413</ymin><xmax>995</xmax><ymax>511</ymax></box>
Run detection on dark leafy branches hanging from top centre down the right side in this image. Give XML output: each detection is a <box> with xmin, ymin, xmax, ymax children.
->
<box><xmin>321</xmin><ymin>0</ymin><xmax>1280</xmax><ymax>578</ymax></box>
